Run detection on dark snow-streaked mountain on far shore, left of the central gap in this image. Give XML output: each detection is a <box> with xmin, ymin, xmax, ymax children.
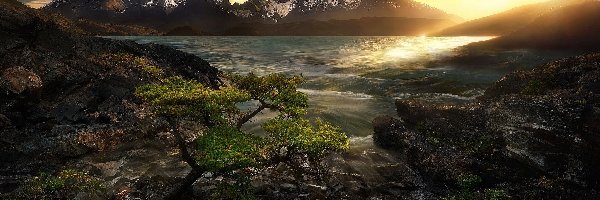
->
<box><xmin>43</xmin><ymin>0</ymin><xmax>238</xmax><ymax>32</ymax></box>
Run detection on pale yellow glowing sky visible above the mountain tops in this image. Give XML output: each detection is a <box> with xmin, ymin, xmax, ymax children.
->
<box><xmin>19</xmin><ymin>0</ymin><xmax>546</xmax><ymax>20</ymax></box>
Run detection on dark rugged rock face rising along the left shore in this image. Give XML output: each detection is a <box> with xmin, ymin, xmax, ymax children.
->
<box><xmin>0</xmin><ymin>0</ymin><xmax>219</xmax><ymax>193</ymax></box>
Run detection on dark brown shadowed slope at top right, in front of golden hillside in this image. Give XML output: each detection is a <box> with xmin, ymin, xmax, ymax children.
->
<box><xmin>475</xmin><ymin>1</ymin><xmax>600</xmax><ymax>50</ymax></box>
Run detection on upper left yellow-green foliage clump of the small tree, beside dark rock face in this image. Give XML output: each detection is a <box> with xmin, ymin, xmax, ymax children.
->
<box><xmin>135</xmin><ymin>76</ymin><xmax>250</xmax><ymax>124</ymax></box>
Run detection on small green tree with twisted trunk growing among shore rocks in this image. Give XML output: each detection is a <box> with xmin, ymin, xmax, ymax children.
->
<box><xmin>136</xmin><ymin>74</ymin><xmax>349</xmax><ymax>199</ymax></box>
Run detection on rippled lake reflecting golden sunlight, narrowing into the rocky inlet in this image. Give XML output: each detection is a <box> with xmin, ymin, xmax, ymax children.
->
<box><xmin>105</xmin><ymin>36</ymin><xmax>574</xmax><ymax>189</ymax></box>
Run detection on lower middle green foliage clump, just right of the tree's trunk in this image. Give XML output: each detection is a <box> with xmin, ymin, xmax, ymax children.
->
<box><xmin>196</xmin><ymin>126</ymin><xmax>263</xmax><ymax>171</ymax></box>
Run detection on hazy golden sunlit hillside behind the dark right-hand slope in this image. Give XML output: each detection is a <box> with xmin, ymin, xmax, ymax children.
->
<box><xmin>436</xmin><ymin>0</ymin><xmax>589</xmax><ymax>36</ymax></box>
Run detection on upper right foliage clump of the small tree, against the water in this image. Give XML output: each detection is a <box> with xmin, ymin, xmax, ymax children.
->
<box><xmin>229</xmin><ymin>73</ymin><xmax>308</xmax><ymax>116</ymax></box>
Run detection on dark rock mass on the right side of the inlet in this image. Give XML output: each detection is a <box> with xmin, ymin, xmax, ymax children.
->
<box><xmin>373</xmin><ymin>54</ymin><xmax>600</xmax><ymax>199</ymax></box>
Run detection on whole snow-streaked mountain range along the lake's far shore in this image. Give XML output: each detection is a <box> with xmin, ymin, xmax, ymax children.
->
<box><xmin>43</xmin><ymin>0</ymin><xmax>461</xmax><ymax>35</ymax></box>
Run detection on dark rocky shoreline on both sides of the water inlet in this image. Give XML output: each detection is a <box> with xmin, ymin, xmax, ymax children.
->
<box><xmin>0</xmin><ymin>0</ymin><xmax>600</xmax><ymax>199</ymax></box>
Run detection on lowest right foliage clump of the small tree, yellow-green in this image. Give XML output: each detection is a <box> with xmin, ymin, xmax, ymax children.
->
<box><xmin>263</xmin><ymin>117</ymin><xmax>349</xmax><ymax>157</ymax></box>
